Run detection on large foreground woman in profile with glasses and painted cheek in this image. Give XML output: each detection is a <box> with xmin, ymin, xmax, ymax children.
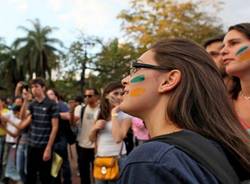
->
<box><xmin>118</xmin><ymin>39</ymin><xmax>250</xmax><ymax>184</ymax></box>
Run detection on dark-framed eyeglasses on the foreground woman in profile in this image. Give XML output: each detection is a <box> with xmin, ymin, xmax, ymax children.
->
<box><xmin>129</xmin><ymin>61</ymin><xmax>173</xmax><ymax>75</ymax></box>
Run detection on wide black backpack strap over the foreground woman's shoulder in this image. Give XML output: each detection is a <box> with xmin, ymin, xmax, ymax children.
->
<box><xmin>152</xmin><ymin>130</ymin><xmax>239</xmax><ymax>184</ymax></box>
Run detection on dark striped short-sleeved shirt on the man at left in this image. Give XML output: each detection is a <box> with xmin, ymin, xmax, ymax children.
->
<box><xmin>29</xmin><ymin>97</ymin><xmax>59</xmax><ymax>148</ymax></box>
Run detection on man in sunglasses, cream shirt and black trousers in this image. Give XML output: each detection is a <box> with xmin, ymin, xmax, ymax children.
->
<box><xmin>75</xmin><ymin>88</ymin><xmax>99</xmax><ymax>184</ymax></box>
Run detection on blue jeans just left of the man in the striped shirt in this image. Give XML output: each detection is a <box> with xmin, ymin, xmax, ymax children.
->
<box><xmin>16</xmin><ymin>144</ymin><xmax>28</xmax><ymax>183</ymax></box>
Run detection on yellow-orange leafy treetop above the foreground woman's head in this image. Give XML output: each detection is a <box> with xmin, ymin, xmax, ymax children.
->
<box><xmin>118</xmin><ymin>0</ymin><xmax>222</xmax><ymax>47</ymax></box>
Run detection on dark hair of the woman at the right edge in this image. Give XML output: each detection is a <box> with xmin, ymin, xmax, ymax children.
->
<box><xmin>228</xmin><ymin>23</ymin><xmax>250</xmax><ymax>100</ymax></box>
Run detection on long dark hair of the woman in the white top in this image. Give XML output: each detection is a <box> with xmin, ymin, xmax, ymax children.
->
<box><xmin>98</xmin><ymin>82</ymin><xmax>123</xmax><ymax>120</ymax></box>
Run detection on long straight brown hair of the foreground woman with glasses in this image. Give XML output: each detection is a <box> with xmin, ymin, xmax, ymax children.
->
<box><xmin>151</xmin><ymin>39</ymin><xmax>250</xmax><ymax>172</ymax></box>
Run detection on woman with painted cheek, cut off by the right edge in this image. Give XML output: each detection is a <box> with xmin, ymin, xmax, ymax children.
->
<box><xmin>221</xmin><ymin>23</ymin><xmax>250</xmax><ymax>133</ymax></box>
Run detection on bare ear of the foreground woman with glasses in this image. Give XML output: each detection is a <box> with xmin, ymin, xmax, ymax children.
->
<box><xmin>158</xmin><ymin>70</ymin><xmax>181</xmax><ymax>93</ymax></box>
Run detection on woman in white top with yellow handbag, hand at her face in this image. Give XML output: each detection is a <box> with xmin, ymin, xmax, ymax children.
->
<box><xmin>90</xmin><ymin>82</ymin><xmax>131</xmax><ymax>184</ymax></box>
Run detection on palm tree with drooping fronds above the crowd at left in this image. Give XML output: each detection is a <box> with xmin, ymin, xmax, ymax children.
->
<box><xmin>14</xmin><ymin>19</ymin><xmax>63</xmax><ymax>81</ymax></box>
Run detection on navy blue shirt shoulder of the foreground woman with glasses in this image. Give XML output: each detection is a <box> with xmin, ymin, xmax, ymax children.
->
<box><xmin>117</xmin><ymin>141</ymin><xmax>219</xmax><ymax>184</ymax></box>
